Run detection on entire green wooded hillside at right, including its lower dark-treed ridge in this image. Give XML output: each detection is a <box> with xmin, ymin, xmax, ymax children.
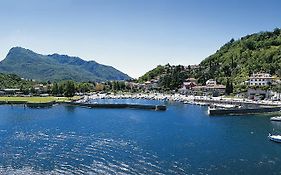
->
<box><xmin>139</xmin><ymin>28</ymin><xmax>281</xmax><ymax>90</ymax></box>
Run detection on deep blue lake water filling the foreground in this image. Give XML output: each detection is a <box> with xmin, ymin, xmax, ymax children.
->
<box><xmin>0</xmin><ymin>100</ymin><xmax>281</xmax><ymax>174</ymax></box>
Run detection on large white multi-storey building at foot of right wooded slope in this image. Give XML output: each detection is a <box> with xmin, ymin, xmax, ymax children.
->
<box><xmin>249</xmin><ymin>73</ymin><xmax>273</xmax><ymax>86</ymax></box>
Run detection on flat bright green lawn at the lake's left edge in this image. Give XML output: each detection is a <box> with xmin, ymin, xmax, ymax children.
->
<box><xmin>0</xmin><ymin>96</ymin><xmax>80</xmax><ymax>103</ymax></box>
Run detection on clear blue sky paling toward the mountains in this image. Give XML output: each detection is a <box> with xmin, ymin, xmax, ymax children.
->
<box><xmin>0</xmin><ymin>0</ymin><xmax>281</xmax><ymax>78</ymax></box>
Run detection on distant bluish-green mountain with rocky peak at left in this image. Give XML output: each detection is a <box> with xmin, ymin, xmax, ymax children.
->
<box><xmin>0</xmin><ymin>47</ymin><xmax>130</xmax><ymax>82</ymax></box>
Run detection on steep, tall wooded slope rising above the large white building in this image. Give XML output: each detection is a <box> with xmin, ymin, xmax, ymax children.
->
<box><xmin>195</xmin><ymin>28</ymin><xmax>281</xmax><ymax>85</ymax></box>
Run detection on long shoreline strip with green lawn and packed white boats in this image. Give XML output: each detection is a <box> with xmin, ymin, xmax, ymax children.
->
<box><xmin>0</xmin><ymin>93</ymin><xmax>281</xmax><ymax>108</ymax></box>
